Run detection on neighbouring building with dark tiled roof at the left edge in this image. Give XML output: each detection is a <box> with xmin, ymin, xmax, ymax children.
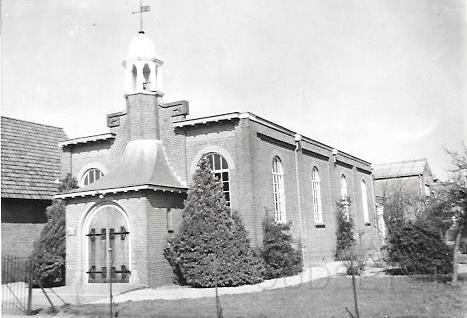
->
<box><xmin>1</xmin><ymin>116</ymin><xmax>67</xmax><ymax>257</ymax></box>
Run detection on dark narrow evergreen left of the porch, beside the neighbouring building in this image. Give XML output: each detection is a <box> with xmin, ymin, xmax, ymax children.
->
<box><xmin>31</xmin><ymin>174</ymin><xmax>77</xmax><ymax>287</ymax></box>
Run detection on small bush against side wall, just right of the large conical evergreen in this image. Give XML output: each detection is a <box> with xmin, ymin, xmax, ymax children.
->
<box><xmin>261</xmin><ymin>217</ymin><xmax>303</xmax><ymax>279</ymax></box>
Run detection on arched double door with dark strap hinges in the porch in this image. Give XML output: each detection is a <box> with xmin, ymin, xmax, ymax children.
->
<box><xmin>85</xmin><ymin>205</ymin><xmax>130</xmax><ymax>283</ymax></box>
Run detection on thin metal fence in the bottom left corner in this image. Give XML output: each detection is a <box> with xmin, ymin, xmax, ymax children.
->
<box><xmin>2</xmin><ymin>255</ymin><xmax>33</xmax><ymax>314</ymax></box>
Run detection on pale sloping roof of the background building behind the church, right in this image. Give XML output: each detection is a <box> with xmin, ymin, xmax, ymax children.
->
<box><xmin>373</xmin><ymin>159</ymin><xmax>428</xmax><ymax>179</ymax></box>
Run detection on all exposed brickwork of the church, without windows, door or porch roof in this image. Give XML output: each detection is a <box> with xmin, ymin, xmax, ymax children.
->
<box><xmin>63</xmin><ymin>95</ymin><xmax>377</xmax><ymax>286</ymax></box>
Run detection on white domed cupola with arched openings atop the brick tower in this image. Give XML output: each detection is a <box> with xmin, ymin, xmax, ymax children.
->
<box><xmin>123</xmin><ymin>31</ymin><xmax>164</xmax><ymax>95</ymax></box>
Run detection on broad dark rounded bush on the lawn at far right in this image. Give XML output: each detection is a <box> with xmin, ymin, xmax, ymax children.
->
<box><xmin>386</xmin><ymin>223</ymin><xmax>452</xmax><ymax>275</ymax></box>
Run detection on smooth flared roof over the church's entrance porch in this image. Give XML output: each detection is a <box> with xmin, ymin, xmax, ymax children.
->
<box><xmin>56</xmin><ymin>140</ymin><xmax>187</xmax><ymax>198</ymax></box>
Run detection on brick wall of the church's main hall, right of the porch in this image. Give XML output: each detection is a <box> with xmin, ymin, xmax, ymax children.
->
<box><xmin>179</xmin><ymin>119</ymin><xmax>378</xmax><ymax>262</ymax></box>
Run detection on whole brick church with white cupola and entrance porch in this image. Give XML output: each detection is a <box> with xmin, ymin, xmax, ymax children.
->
<box><xmin>56</xmin><ymin>31</ymin><xmax>378</xmax><ymax>287</ymax></box>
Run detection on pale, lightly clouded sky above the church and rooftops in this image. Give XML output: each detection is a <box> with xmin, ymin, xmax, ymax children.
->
<box><xmin>1</xmin><ymin>0</ymin><xmax>467</xmax><ymax>179</ymax></box>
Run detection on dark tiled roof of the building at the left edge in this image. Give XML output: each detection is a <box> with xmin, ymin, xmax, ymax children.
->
<box><xmin>1</xmin><ymin>116</ymin><xmax>67</xmax><ymax>199</ymax></box>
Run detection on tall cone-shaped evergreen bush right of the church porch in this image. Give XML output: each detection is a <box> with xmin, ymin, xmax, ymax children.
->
<box><xmin>164</xmin><ymin>159</ymin><xmax>264</xmax><ymax>287</ymax></box>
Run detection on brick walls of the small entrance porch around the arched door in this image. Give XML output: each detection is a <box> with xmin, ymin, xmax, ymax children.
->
<box><xmin>66</xmin><ymin>192</ymin><xmax>184</xmax><ymax>286</ymax></box>
